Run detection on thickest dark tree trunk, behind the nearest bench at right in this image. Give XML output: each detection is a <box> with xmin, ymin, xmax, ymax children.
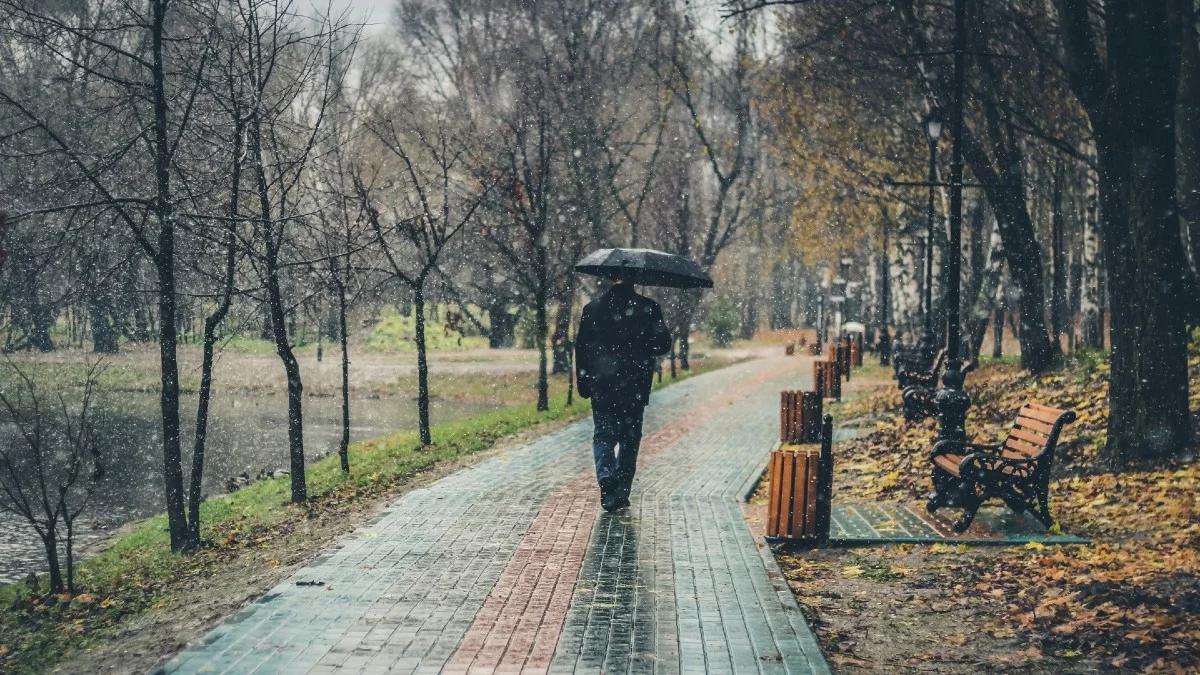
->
<box><xmin>1093</xmin><ymin>2</ymin><xmax>1192</xmax><ymax>468</ymax></box>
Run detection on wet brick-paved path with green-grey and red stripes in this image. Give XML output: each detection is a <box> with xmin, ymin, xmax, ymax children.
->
<box><xmin>161</xmin><ymin>357</ymin><xmax>828</xmax><ymax>674</ymax></box>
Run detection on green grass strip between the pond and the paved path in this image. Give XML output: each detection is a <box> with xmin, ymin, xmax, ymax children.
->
<box><xmin>0</xmin><ymin>359</ymin><xmax>728</xmax><ymax>673</ymax></box>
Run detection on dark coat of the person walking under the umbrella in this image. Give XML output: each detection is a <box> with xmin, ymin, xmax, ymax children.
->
<box><xmin>575</xmin><ymin>283</ymin><xmax>671</xmax><ymax>406</ymax></box>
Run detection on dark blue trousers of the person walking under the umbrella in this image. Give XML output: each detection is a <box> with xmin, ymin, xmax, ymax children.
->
<box><xmin>592</xmin><ymin>394</ymin><xmax>646</xmax><ymax>498</ymax></box>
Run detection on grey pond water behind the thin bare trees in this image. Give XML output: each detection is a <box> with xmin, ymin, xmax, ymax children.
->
<box><xmin>0</xmin><ymin>394</ymin><xmax>502</xmax><ymax>583</ymax></box>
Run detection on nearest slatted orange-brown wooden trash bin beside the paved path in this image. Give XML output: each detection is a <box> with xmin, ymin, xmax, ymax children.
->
<box><xmin>767</xmin><ymin>417</ymin><xmax>833</xmax><ymax>544</ymax></box>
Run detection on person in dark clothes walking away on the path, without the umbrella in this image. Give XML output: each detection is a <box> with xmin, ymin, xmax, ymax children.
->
<box><xmin>575</xmin><ymin>280</ymin><xmax>671</xmax><ymax>512</ymax></box>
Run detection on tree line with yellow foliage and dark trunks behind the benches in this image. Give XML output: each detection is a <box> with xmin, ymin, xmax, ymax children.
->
<box><xmin>739</xmin><ymin>0</ymin><xmax>1200</xmax><ymax>468</ymax></box>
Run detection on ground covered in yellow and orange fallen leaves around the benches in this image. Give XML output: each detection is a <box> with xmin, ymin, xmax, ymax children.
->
<box><xmin>779</xmin><ymin>341</ymin><xmax>1200</xmax><ymax>673</ymax></box>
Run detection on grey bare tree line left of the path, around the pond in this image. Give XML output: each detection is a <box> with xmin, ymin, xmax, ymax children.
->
<box><xmin>0</xmin><ymin>0</ymin><xmax>799</xmax><ymax>585</ymax></box>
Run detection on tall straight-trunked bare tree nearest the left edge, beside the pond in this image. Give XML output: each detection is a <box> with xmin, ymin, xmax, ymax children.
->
<box><xmin>0</xmin><ymin>0</ymin><xmax>211</xmax><ymax>551</ymax></box>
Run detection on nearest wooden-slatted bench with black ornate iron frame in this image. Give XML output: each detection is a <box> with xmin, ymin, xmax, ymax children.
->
<box><xmin>925</xmin><ymin>402</ymin><xmax>1075</xmax><ymax>532</ymax></box>
